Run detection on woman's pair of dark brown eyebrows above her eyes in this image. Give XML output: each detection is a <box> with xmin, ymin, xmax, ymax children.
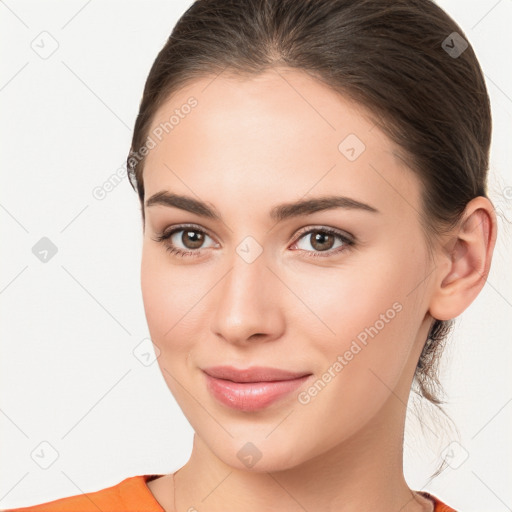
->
<box><xmin>145</xmin><ymin>190</ymin><xmax>380</xmax><ymax>222</ymax></box>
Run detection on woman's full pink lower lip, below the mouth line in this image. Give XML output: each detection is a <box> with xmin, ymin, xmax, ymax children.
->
<box><xmin>205</xmin><ymin>373</ymin><xmax>311</xmax><ymax>411</ymax></box>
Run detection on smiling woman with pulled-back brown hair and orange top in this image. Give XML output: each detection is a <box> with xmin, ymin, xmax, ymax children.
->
<box><xmin>4</xmin><ymin>0</ymin><xmax>496</xmax><ymax>512</ymax></box>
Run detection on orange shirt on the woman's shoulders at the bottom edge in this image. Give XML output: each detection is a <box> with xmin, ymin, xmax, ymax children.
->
<box><xmin>5</xmin><ymin>475</ymin><xmax>456</xmax><ymax>512</ymax></box>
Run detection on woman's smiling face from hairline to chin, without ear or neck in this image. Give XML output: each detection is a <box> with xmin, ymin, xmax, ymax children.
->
<box><xmin>141</xmin><ymin>69</ymin><xmax>433</xmax><ymax>471</ymax></box>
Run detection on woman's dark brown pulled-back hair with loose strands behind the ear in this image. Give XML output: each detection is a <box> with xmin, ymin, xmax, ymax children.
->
<box><xmin>127</xmin><ymin>0</ymin><xmax>491</xmax><ymax>416</ymax></box>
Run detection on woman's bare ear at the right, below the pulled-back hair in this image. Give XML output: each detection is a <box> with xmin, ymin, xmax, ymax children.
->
<box><xmin>429</xmin><ymin>196</ymin><xmax>497</xmax><ymax>320</ymax></box>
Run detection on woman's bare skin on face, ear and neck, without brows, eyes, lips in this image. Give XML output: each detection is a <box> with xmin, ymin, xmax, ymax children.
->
<box><xmin>141</xmin><ymin>68</ymin><xmax>496</xmax><ymax>512</ymax></box>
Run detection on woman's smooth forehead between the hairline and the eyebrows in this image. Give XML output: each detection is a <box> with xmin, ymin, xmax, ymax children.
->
<box><xmin>144</xmin><ymin>69</ymin><xmax>420</xmax><ymax>218</ymax></box>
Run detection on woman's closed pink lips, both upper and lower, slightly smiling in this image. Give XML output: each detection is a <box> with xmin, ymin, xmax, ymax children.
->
<box><xmin>203</xmin><ymin>366</ymin><xmax>312</xmax><ymax>412</ymax></box>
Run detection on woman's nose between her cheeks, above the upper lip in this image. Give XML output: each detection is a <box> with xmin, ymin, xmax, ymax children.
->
<box><xmin>211</xmin><ymin>247</ymin><xmax>285</xmax><ymax>344</ymax></box>
